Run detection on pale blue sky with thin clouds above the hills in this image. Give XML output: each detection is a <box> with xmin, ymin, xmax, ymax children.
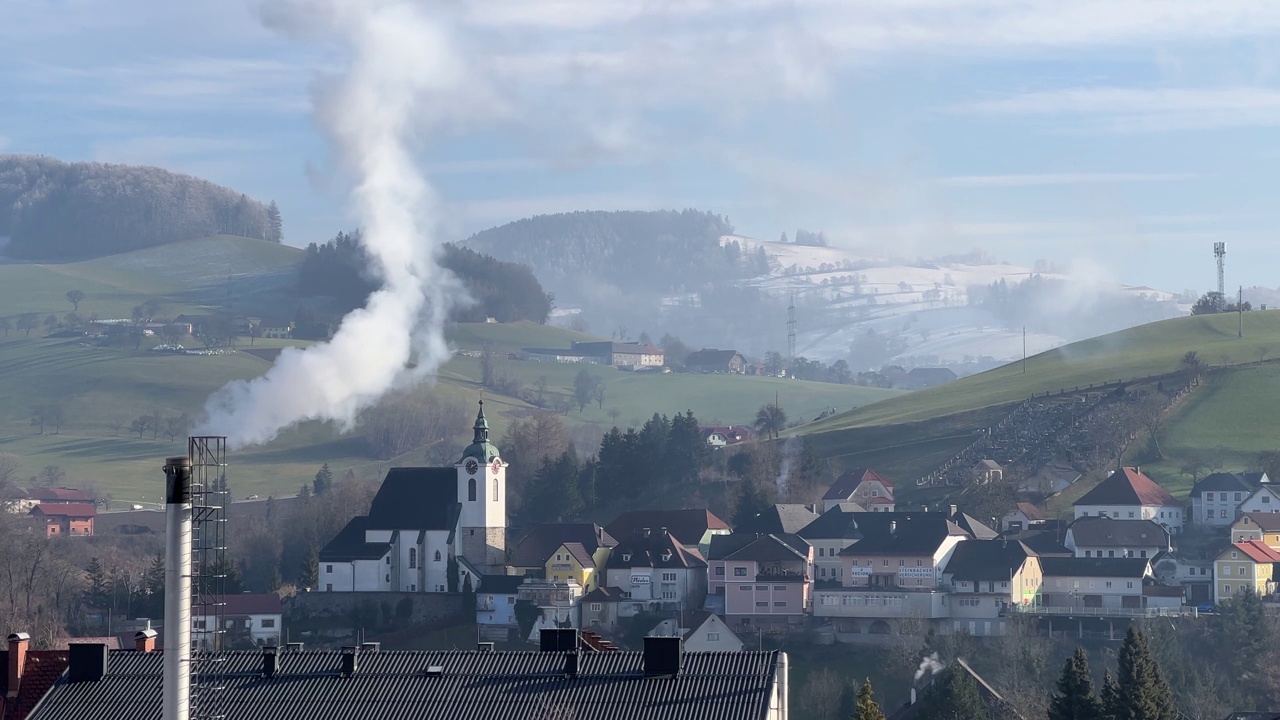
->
<box><xmin>0</xmin><ymin>0</ymin><xmax>1280</xmax><ymax>291</ymax></box>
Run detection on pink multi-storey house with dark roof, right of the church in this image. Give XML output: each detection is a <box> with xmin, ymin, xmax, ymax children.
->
<box><xmin>707</xmin><ymin>533</ymin><xmax>813</xmax><ymax>628</ymax></box>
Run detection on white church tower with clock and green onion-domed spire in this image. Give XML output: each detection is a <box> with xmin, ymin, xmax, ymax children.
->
<box><xmin>456</xmin><ymin>400</ymin><xmax>507</xmax><ymax>575</ymax></box>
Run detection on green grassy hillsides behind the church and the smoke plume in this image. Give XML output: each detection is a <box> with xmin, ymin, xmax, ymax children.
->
<box><xmin>0</xmin><ymin>236</ymin><xmax>897</xmax><ymax>505</ymax></box>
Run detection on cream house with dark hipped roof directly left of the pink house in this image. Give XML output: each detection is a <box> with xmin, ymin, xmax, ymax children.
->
<box><xmin>603</xmin><ymin>528</ymin><xmax>707</xmax><ymax>618</ymax></box>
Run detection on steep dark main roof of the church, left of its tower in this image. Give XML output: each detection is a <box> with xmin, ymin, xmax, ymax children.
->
<box><xmin>369</xmin><ymin>468</ymin><xmax>461</xmax><ymax>530</ymax></box>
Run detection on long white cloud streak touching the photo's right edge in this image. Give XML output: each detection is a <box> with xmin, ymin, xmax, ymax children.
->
<box><xmin>951</xmin><ymin>87</ymin><xmax>1280</xmax><ymax>132</ymax></box>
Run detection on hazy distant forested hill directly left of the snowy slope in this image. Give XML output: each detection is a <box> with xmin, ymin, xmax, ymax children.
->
<box><xmin>462</xmin><ymin>210</ymin><xmax>768</xmax><ymax>300</ymax></box>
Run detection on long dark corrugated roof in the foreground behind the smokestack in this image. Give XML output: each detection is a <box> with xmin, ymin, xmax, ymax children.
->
<box><xmin>31</xmin><ymin>651</ymin><xmax>778</xmax><ymax>720</ymax></box>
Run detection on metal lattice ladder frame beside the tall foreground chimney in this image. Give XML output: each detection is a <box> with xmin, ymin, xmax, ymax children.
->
<box><xmin>188</xmin><ymin>436</ymin><xmax>230</xmax><ymax>720</ymax></box>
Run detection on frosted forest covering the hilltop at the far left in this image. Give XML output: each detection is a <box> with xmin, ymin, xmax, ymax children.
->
<box><xmin>0</xmin><ymin>155</ymin><xmax>283</xmax><ymax>259</ymax></box>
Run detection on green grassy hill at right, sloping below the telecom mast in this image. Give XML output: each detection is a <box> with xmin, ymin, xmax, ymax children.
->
<box><xmin>791</xmin><ymin>311</ymin><xmax>1280</xmax><ymax>495</ymax></box>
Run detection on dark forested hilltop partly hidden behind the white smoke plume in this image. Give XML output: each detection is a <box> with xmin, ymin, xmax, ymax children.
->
<box><xmin>298</xmin><ymin>231</ymin><xmax>552</xmax><ymax>323</ymax></box>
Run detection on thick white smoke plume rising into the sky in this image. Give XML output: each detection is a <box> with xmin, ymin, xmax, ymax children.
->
<box><xmin>197</xmin><ymin>0</ymin><xmax>483</xmax><ymax>446</ymax></box>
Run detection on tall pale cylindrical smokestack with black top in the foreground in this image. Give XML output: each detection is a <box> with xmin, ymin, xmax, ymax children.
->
<box><xmin>161</xmin><ymin>457</ymin><xmax>191</xmax><ymax>720</ymax></box>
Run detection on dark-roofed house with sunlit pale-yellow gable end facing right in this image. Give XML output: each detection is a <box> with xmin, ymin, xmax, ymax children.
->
<box><xmin>942</xmin><ymin>538</ymin><xmax>1044</xmax><ymax>635</ymax></box>
